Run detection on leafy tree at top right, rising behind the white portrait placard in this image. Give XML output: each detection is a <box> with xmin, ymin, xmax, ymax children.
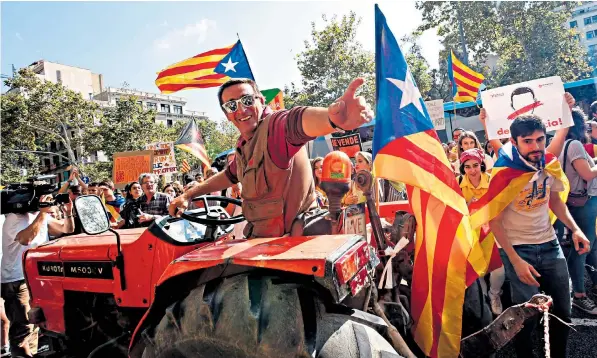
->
<box><xmin>416</xmin><ymin>1</ymin><xmax>591</xmax><ymax>87</ymax></box>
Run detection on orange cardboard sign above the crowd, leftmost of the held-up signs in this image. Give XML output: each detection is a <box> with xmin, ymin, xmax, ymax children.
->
<box><xmin>112</xmin><ymin>150</ymin><xmax>153</xmax><ymax>189</ymax></box>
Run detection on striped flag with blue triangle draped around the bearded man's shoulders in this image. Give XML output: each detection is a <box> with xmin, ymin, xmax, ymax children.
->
<box><xmin>467</xmin><ymin>143</ymin><xmax>570</xmax><ymax>281</ymax></box>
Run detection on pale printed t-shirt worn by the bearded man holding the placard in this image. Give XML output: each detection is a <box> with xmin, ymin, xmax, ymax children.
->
<box><xmin>502</xmin><ymin>172</ymin><xmax>564</xmax><ymax>245</ymax></box>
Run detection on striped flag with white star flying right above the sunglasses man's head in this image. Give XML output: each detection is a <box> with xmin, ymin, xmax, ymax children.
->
<box><xmin>155</xmin><ymin>40</ymin><xmax>255</xmax><ymax>93</ymax></box>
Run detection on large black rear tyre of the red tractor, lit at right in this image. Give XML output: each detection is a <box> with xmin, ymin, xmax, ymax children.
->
<box><xmin>143</xmin><ymin>275</ymin><xmax>400</xmax><ymax>358</ymax></box>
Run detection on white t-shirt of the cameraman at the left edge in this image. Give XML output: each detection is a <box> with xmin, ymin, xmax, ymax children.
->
<box><xmin>2</xmin><ymin>213</ymin><xmax>48</xmax><ymax>283</ymax></box>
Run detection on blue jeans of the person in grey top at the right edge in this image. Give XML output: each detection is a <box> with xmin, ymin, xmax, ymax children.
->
<box><xmin>568</xmin><ymin>196</ymin><xmax>597</xmax><ymax>293</ymax></box>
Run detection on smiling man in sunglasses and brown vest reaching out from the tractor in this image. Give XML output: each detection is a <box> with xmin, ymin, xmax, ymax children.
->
<box><xmin>169</xmin><ymin>78</ymin><xmax>373</xmax><ymax>237</ymax></box>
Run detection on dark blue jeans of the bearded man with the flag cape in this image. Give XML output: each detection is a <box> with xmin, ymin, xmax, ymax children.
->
<box><xmin>500</xmin><ymin>241</ymin><xmax>571</xmax><ymax>358</ymax></box>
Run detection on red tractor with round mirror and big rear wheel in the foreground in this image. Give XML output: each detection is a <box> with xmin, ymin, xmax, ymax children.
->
<box><xmin>23</xmin><ymin>161</ymin><xmax>544</xmax><ymax>358</ymax></box>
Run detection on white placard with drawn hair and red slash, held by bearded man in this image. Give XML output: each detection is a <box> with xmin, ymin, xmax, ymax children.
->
<box><xmin>481</xmin><ymin>76</ymin><xmax>573</xmax><ymax>139</ymax></box>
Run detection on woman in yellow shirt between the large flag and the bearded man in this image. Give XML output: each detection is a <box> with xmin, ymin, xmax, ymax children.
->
<box><xmin>458</xmin><ymin>148</ymin><xmax>505</xmax><ymax>315</ymax></box>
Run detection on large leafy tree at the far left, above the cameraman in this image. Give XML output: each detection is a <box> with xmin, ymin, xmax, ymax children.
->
<box><xmin>0</xmin><ymin>69</ymin><xmax>101</xmax><ymax>183</ymax></box>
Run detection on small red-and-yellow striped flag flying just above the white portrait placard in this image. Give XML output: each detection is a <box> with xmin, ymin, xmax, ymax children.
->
<box><xmin>448</xmin><ymin>51</ymin><xmax>485</xmax><ymax>102</ymax></box>
